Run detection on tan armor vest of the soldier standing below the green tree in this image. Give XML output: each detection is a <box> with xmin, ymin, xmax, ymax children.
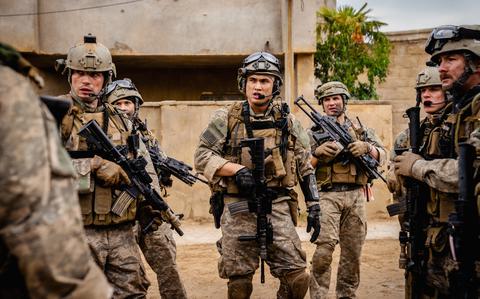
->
<box><xmin>315</xmin><ymin>119</ymin><xmax>368</xmax><ymax>190</ymax></box>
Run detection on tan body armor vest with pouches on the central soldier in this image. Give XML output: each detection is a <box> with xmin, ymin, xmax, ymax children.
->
<box><xmin>224</xmin><ymin>102</ymin><xmax>297</xmax><ymax>194</ymax></box>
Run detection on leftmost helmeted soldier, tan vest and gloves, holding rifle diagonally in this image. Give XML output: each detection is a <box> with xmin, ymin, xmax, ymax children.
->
<box><xmin>57</xmin><ymin>35</ymin><xmax>158</xmax><ymax>298</ymax></box>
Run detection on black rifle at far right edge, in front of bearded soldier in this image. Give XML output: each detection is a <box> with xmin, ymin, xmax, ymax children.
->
<box><xmin>449</xmin><ymin>143</ymin><xmax>479</xmax><ymax>299</ymax></box>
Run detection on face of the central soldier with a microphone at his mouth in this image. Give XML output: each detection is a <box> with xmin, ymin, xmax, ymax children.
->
<box><xmin>245</xmin><ymin>74</ymin><xmax>275</xmax><ymax>112</ymax></box>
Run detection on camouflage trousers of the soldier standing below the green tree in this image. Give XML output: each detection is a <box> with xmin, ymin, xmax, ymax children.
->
<box><xmin>310</xmin><ymin>188</ymin><xmax>367</xmax><ymax>299</ymax></box>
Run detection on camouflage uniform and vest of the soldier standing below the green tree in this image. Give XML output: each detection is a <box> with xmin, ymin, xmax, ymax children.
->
<box><xmin>309</xmin><ymin>119</ymin><xmax>386</xmax><ymax>298</ymax></box>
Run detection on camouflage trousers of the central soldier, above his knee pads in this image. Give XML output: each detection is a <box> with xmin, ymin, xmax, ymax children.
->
<box><xmin>218</xmin><ymin>201</ymin><xmax>306</xmax><ymax>278</ymax></box>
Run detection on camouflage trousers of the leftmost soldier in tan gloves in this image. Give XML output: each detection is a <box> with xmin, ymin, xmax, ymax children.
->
<box><xmin>85</xmin><ymin>223</ymin><xmax>150</xmax><ymax>299</ymax></box>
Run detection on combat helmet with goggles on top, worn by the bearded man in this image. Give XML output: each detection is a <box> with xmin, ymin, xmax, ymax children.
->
<box><xmin>425</xmin><ymin>25</ymin><xmax>480</xmax><ymax>64</ymax></box>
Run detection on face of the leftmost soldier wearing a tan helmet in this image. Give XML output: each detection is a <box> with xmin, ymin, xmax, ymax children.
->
<box><xmin>71</xmin><ymin>70</ymin><xmax>105</xmax><ymax>102</ymax></box>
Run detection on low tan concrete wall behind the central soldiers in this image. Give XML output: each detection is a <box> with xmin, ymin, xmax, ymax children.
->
<box><xmin>141</xmin><ymin>101</ymin><xmax>392</xmax><ymax>220</ymax></box>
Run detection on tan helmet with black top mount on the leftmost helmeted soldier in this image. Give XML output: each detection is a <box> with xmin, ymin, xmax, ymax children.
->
<box><xmin>55</xmin><ymin>33</ymin><xmax>116</xmax><ymax>82</ymax></box>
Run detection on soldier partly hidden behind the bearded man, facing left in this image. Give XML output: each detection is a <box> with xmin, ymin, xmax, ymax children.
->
<box><xmin>387</xmin><ymin>66</ymin><xmax>452</xmax><ymax>226</ymax></box>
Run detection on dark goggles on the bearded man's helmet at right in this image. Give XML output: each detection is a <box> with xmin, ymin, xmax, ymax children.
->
<box><xmin>425</xmin><ymin>25</ymin><xmax>480</xmax><ymax>55</ymax></box>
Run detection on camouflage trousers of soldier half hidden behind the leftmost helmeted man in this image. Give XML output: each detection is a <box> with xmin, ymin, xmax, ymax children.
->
<box><xmin>139</xmin><ymin>222</ymin><xmax>187</xmax><ymax>299</ymax></box>
